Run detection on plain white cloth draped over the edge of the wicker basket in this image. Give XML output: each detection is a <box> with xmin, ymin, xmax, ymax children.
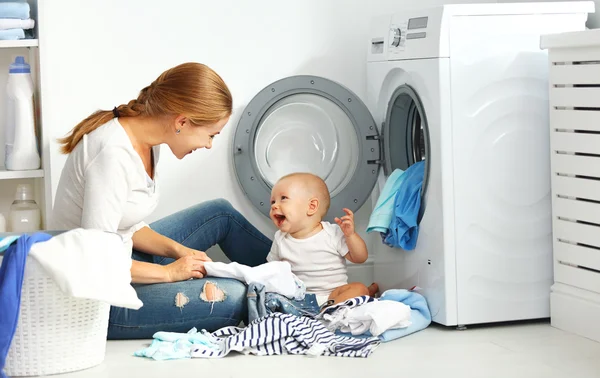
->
<box><xmin>29</xmin><ymin>229</ymin><xmax>143</xmax><ymax>310</ymax></box>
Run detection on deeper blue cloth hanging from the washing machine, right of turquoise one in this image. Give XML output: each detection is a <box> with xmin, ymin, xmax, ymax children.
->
<box><xmin>385</xmin><ymin>161</ymin><xmax>425</xmax><ymax>251</ymax></box>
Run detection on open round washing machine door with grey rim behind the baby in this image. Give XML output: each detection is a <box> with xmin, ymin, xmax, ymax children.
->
<box><xmin>233</xmin><ymin>76</ymin><xmax>381</xmax><ymax>221</ymax></box>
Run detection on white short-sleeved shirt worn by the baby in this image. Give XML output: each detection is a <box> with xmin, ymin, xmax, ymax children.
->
<box><xmin>267</xmin><ymin>222</ymin><xmax>348</xmax><ymax>296</ymax></box>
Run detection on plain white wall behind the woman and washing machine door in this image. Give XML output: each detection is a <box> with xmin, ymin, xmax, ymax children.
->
<box><xmin>40</xmin><ymin>0</ymin><xmax>592</xmax><ymax>280</ymax></box>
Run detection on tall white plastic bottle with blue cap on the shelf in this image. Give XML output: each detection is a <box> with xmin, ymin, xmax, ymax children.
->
<box><xmin>4</xmin><ymin>56</ymin><xmax>40</xmax><ymax>171</ymax></box>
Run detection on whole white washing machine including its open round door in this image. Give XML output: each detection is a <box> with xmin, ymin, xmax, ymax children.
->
<box><xmin>232</xmin><ymin>2</ymin><xmax>594</xmax><ymax>325</ymax></box>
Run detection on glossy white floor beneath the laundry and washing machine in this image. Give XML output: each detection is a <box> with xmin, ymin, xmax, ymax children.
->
<box><xmin>50</xmin><ymin>322</ymin><xmax>600</xmax><ymax>378</ymax></box>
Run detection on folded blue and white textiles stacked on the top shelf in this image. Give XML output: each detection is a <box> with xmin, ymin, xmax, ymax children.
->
<box><xmin>0</xmin><ymin>1</ymin><xmax>35</xmax><ymax>40</ymax></box>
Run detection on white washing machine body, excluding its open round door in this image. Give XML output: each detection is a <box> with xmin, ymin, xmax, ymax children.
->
<box><xmin>367</xmin><ymin>2</ymin><xmax>594</xmax><ymax>325</ymax></box>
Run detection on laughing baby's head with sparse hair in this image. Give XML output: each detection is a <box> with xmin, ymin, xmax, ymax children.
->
<box><xmin>271</xmin><ymin>173</ymin><xmax>330</xmax><ymax>233</ymax></box>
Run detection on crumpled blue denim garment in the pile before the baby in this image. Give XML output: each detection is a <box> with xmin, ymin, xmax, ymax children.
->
<box><xmin>248</xmin><ymin>283</ymin><xmax>320</xmax><ymax>323</ymax></box>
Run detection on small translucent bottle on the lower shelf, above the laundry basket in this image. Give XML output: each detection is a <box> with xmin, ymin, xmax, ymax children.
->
<box><xmin>8</xmin><ymin>184</ymin><xmax>42</xmax><ymax>233</ymax></box>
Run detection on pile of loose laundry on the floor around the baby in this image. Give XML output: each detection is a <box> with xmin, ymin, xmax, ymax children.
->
<box><xmin>134</xmin><ymin>261</ymin><xmax>431</xmax><ymax>360</ymax></box>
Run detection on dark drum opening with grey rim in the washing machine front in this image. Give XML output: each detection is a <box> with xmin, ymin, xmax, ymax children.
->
<box><xmin>382</xmin><ymin>84</ymin><xmax>431</xmax><ymax>223</ymax></box>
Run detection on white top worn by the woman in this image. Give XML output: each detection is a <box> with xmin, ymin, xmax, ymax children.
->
<box><xmin>52</xmin><ymin>118</ymin><xmax>159</xmax><ymax>248</ymax></box>
